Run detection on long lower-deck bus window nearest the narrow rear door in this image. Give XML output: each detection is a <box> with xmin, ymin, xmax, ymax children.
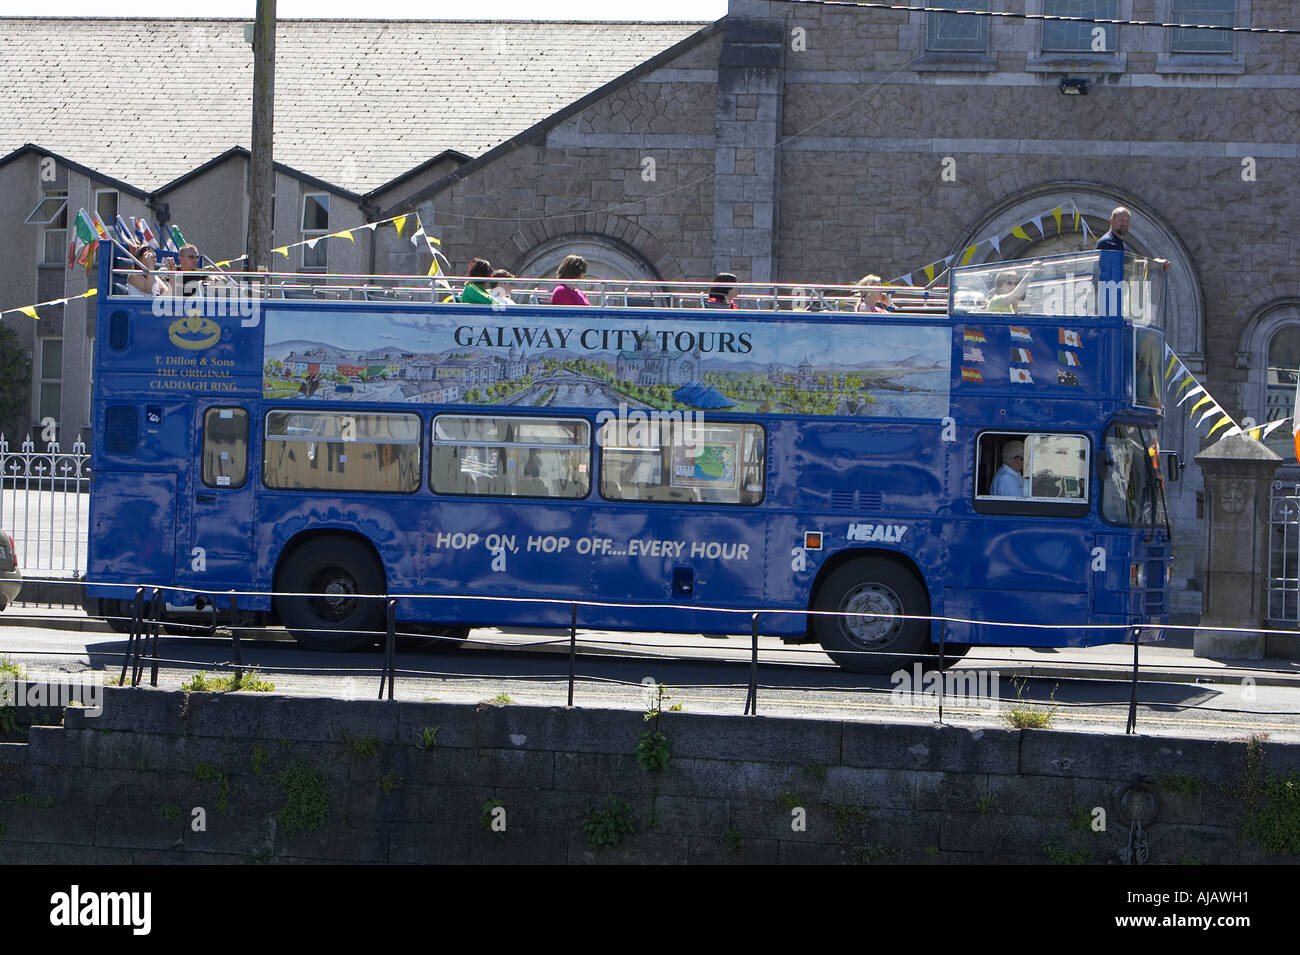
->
<box><xmin>263</xmin><ymin>411</ymin><xmax>420</xmax><ymax>494</ymax></box>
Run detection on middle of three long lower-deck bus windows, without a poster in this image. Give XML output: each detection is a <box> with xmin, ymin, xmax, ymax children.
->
<box><xmin>429</xmin><ymin>414</ymin><xmax>592</xmax><ymax>499</ymax></box>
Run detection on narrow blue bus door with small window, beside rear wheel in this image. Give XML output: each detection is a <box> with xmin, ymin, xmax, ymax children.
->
<box><xmin>177</xmin><ymin>405</ymin><xmax>256</xmax><ymax>591</ymax></box>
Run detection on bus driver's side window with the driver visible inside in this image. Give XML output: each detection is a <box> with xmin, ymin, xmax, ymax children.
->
<box><xmin>975</xmin><ymin>433</ymin><xmax>1089</xmax><ymax>513</ymax></box>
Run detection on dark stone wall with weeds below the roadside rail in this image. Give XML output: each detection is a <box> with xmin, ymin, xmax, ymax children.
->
<box><xmin>0</xmin><ymin>687</ymin><xmax>1300</xmax><ymax>863</ymax></box>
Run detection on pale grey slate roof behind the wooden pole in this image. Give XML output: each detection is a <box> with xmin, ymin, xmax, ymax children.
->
<box><xmin>0</xmin><ymin>17</ymin><xmax>707</xmax><ymax>192</ymax></box>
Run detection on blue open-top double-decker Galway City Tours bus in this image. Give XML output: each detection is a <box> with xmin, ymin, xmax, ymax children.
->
<box><xmin>86</xmin><ymin>244</ymin><xmax>1170</xmax><ymax>672</ymax></box>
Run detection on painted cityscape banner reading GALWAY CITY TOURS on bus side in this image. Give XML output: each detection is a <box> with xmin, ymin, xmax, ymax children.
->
<box><xmin>263</xmin><ymin>307</ymin><xmax>952</xmax><ymax>418</ymax></box>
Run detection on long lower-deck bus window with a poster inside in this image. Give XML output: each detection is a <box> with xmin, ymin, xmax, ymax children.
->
<box><xmin>599</xmin><ymin>420</ymin><xmax>767</xmax><ymax>507</ymax></box>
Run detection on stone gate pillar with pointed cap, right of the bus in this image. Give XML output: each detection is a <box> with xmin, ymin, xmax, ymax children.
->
<box><xmin>1195</xmin><ymin>434</ymin><xmax>1282</xmax><ymax>660</ymax></box>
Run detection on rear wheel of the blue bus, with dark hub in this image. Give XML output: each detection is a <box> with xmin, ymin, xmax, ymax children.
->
<box><xmin>276</xmin><ymin>538</ymin><xmax>387</xmax><ymax>650</ymax></box>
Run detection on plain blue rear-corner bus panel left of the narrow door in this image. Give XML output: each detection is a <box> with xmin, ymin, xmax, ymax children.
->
<box><xmin>88</xmin><ymin>470</ymin><xmax>177</xmax><ymax>587</ymax></box>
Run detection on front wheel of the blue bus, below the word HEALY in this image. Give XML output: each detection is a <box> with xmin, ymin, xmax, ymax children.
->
<box><xmin>813</xmin><ymin>557</ymin><xmax>937</xmax><ymax>673</ymax></box>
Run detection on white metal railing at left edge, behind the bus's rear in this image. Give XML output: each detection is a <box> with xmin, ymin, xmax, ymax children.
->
<box><xmin>0</xmin><ymin>435</ymin><xmax>90</xmax><ymax>578</ymax></box>
